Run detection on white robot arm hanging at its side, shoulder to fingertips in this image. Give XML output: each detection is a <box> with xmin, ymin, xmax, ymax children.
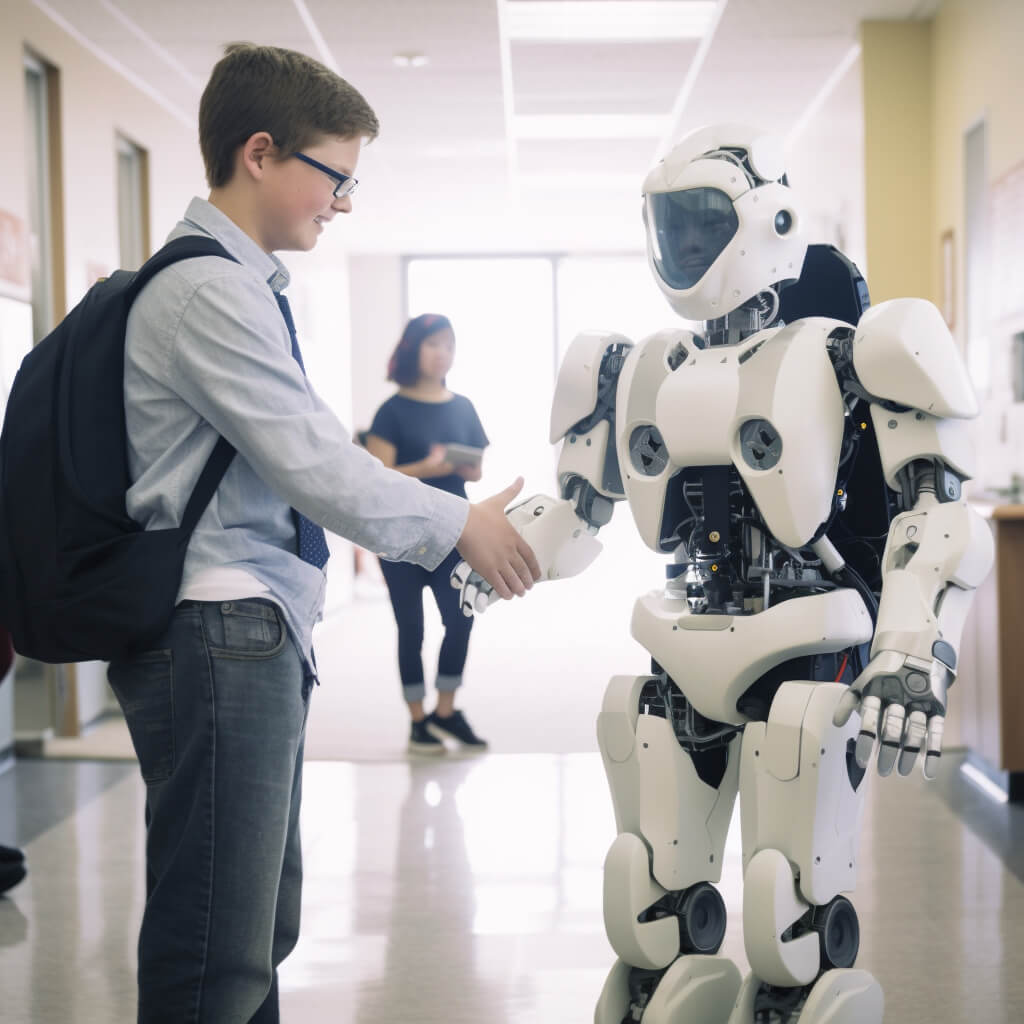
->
<box><xmin>835</xmin><ymin>299</ymin><xmax>993</xmax><ymax>778</ymax></box>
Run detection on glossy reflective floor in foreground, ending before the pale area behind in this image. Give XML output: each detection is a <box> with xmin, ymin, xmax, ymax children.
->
<box><xmin>0</xmin><ymin>754</ymin><xmax>1024</xmax><ymax>1024</ymax></box>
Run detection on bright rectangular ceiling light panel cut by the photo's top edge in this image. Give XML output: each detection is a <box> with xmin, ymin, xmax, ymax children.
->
<box><xmin>504</xmin><ymin>0</ymin><xmax>716</xmax><ymax>42</ymax></box>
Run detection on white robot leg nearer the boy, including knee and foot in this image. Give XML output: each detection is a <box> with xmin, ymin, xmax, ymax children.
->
<box><xmin>594</xmin><ymin>676</ymin><xmax>740</xmax><ymax>1024</ymax></box>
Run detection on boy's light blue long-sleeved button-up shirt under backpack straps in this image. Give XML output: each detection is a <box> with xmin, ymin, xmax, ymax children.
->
<box><xmin>125</xmin><ymin>199</ymin><xmax>469</xmax><ymax>662</ymax></box>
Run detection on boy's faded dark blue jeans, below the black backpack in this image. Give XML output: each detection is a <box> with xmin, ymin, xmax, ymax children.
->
<box><xmin>109</xmin><ymin>598</ymin><xmax>312</xmax><ymax>1024</ymax></box>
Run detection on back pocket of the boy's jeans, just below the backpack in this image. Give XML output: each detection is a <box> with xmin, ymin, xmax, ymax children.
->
<box><xmin>106</xmin><ymin>650</ymin><xmax>174</xmax><ymax>782</ymax></box>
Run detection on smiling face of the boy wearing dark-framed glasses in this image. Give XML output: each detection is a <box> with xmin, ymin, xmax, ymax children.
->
<box><xmin>256</xmin><ymin>136</ymin><xmax>362</xmax><ymax>253</ymax></box>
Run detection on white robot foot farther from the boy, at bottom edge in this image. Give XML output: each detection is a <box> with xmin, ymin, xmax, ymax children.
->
<box><xmin>728</xmin><ymin>968</ymin><xmax>885</xmax><ymax>1024</ymax></box>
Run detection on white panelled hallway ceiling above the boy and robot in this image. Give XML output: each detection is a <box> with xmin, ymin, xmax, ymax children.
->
<box><xmin>33</xmin><ymin>0</ymin><xmax>939</xmax><ymax>253</ymax></box>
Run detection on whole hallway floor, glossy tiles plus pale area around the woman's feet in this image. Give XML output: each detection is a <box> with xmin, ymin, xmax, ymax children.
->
<box><xmin>0</xmin><ymin>541</ymin><xmax>1024</xmax><ymax>1024</ymax></box>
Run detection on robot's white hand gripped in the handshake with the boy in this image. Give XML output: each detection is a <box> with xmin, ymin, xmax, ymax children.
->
<box><xmin>452</xmin><ymin>495</ymin><xmax>601</xmax><ymax>615</ymax></box>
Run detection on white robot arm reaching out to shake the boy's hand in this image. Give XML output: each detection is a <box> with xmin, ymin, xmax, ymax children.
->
<box><xmin>452</xmin><ymin>332</ymin><xmax>632</xmax><ymax>615</ymax></box>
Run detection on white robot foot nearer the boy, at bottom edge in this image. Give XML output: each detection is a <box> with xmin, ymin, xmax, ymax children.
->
<box><xmin>594</xmin><ymin>956</ymin><xmax>740</xmax><ymax>1024</ymax></box>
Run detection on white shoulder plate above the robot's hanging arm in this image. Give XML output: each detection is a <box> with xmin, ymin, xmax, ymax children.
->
<box><xmin>853</xmin><ymin>299</ymin><xmax>978</xmax><ymax>420</ymax></box>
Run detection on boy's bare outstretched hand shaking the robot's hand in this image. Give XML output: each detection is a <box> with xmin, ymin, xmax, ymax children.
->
<box><xmin>456</xmin><ymin>476</ymin><xmax>541</xmax><ymax>600</ymax></box>
